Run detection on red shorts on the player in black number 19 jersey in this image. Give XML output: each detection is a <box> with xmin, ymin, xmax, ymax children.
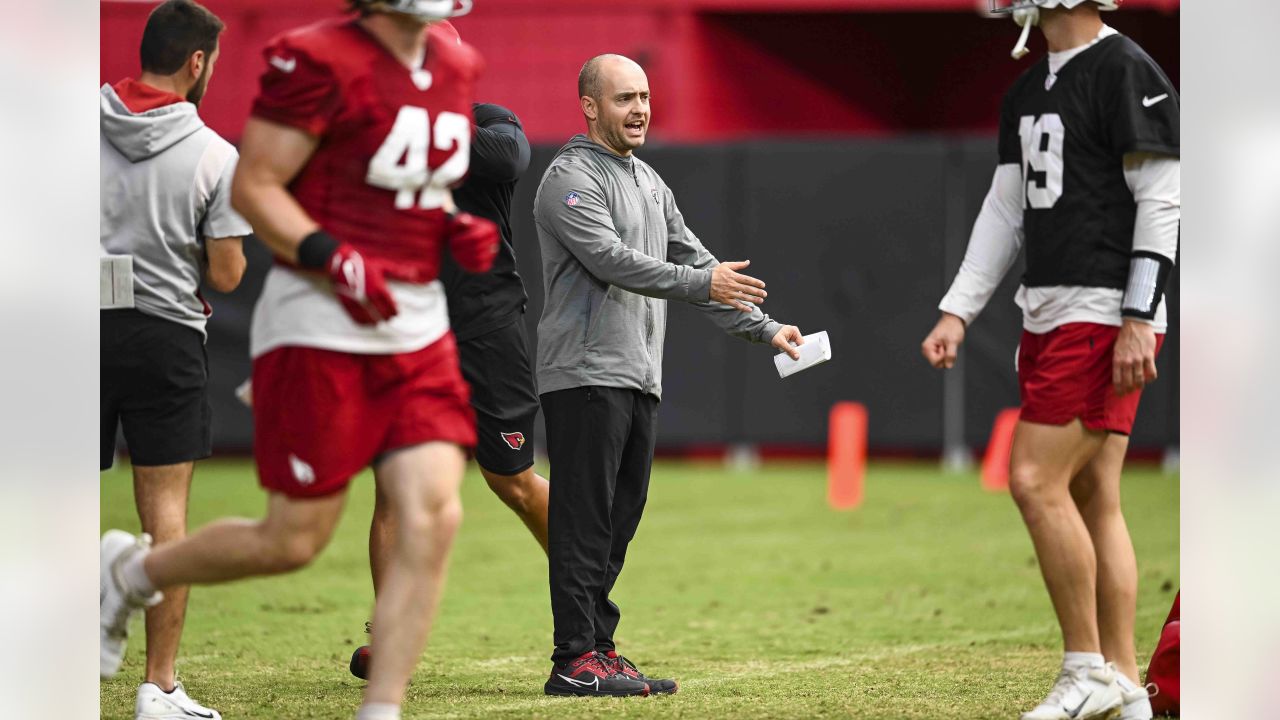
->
<box><xmin>1018</xmin><ymin>323</ymin><xmax>1165</xmax><ymax>436</ymax></box>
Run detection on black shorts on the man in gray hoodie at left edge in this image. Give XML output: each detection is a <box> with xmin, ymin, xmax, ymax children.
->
<box><xmin>99</xmin><ymin>310</ymin><xmax>212</xmax><ymax>470</ymax></box>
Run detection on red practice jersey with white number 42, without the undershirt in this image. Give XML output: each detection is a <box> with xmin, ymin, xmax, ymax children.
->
<box><xmin>253</xmin><ymin>19</ymin><xmax>483</xmax><ymax>279</ymax></box>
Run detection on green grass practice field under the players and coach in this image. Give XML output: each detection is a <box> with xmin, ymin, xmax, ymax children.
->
<box><xmin>101</xmin><ymin>461</ymin><xmax>1179</xmax><ymax>720</ymax></box>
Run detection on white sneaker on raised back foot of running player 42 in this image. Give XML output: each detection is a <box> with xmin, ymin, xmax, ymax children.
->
<box><xmin>97</xmin><ymin>530</ymin><xmax>163</xmax><ymax>680</ymax></box>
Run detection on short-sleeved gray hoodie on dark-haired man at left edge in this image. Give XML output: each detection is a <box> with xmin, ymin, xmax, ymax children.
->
<box><xmin>100</xmin><ymin>85</ymin><xmax>252</xmax><ymax>333</ymax></box>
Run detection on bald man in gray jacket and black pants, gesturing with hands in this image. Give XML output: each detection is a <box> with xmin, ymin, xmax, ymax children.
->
<box><xmin>534</xmin><ymin>55</ymin><xmax>804</xmax><ymax>696</ymax></box>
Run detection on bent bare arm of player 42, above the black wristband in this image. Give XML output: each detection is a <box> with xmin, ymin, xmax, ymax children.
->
<box><xmin>234</xmin><ymin>118</ymin><xmax>320</xmax><ymax>264</ymax></box>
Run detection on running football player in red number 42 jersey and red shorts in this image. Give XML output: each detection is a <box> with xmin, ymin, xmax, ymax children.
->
<box><xmin>101</xmin><ymin>0</ymin><xmax>498</xmax><ymax>720</ymax></box>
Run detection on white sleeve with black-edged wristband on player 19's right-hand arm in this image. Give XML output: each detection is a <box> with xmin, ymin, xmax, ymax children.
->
<box><xmin>1121</xmin><ymin>152</ymin><xmax>1183</xmax><ymax>322</ymax></box>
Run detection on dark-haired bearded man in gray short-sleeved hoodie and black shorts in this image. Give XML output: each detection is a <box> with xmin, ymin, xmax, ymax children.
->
<box><xmin>99</xmin><ymin>0</ymin><xmax>251</xmax><ymax>720</ymax></box>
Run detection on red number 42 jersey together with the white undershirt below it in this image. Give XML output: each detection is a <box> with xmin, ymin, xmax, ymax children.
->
<box><xmin>250</xmin><ymin>19</ymin><xmax>481</xmax><ymax>357</ymax></box>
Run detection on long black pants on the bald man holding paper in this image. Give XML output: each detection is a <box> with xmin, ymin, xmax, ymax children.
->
<box><xmin>541</xmin><ymin>387</ymin><xmax>658</xmax><ymax>662</ymax></box>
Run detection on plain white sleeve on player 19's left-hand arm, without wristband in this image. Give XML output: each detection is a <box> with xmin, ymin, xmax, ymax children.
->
<box><xmin>938</xmin><ymin>164</ymin><xmax>1024</xmax><ymax>325</ymax></box>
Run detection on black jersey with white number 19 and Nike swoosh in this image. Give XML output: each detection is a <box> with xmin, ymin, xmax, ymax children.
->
<box><xmin>1000</xmin><ymin>35</ymin><xmax>1180</xmax><ymax>290</ymax></box>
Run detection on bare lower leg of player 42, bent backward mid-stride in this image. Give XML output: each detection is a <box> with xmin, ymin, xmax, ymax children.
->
<box><xmin>143</xmin><ymin>493</ymin><xmax>346</xmax><ymax>589</ymax></box>
